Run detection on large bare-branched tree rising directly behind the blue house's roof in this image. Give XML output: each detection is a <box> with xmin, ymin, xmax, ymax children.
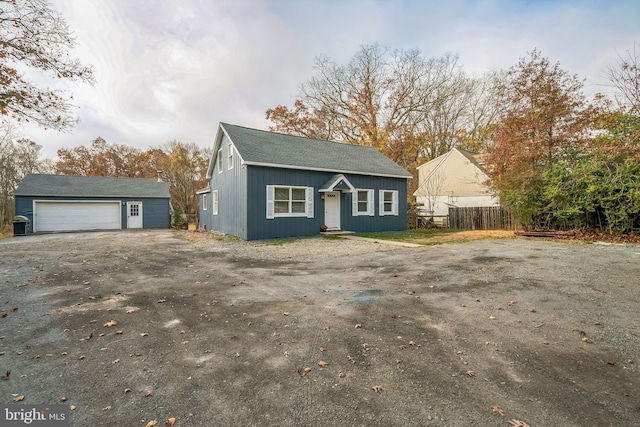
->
<box><xmin>266</xmin><ymin>44</ymin><xmax>500</xmax><ymax>169</ymax></box>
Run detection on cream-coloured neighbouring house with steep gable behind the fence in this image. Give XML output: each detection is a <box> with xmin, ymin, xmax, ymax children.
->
<box><xmin>413</xmin><ymin>148</ymin><xmax>500</xmax><ymax>224</ymax></box>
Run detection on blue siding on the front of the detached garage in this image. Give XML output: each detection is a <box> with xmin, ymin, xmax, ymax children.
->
<box><xmin>15</xmin><ymin>196</ymin><xmax>171</xmax><ymax>229</ymax></box>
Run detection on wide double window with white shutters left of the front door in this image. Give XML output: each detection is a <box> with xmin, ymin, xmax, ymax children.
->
<box><xmin>267</xmin><ymin>185</ymin><xmax>314</xmax><ymax>219</ymax></box>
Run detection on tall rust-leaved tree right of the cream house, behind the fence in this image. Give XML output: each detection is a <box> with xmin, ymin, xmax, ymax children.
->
<box><xmin>487</xmin><ymin>50</ymin><xmax>595</xmax><ymax>224</ymax></box>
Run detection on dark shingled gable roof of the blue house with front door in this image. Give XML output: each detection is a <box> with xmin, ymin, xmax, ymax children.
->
<box><xmin>214</xmin><ymin>123</ymin><xmax>412</xmax><ymax>178</ymax></box>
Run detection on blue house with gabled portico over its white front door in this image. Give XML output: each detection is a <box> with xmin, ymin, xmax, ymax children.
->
<box><xmin>198</xmin><ymin>123</ymin><xmax>412</xmax><ymax>240</ymax></box>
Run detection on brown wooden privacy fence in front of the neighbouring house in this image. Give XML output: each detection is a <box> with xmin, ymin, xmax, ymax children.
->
<box><xmin>449</xmin><ymin>206</ymin><xmax>516</xmax><ymax>230</ymax></box>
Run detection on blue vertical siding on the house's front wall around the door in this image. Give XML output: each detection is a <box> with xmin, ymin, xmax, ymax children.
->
<box><xmin>242</xmin><ymin>166</ymin><xmax>407</xmax><ymax>240</ymax></box>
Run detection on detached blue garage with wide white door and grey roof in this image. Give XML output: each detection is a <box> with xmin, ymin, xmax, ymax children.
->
<box><xmin>15</xmin><ymin>174</ymin><xmax>171</xmax><ymax>233</ymax></box>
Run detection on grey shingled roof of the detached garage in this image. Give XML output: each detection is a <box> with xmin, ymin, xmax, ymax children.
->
<box><xmin>15</xmin><ymin>174</ymin><xmax>169</xmax><ymax>198</ymax></box>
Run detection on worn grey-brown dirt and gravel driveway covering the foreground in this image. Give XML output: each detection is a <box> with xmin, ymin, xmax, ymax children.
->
<box><xmin>0</xmin><ymin>231</ymin><xmax>640</xmax><ymax>427</ymax></box>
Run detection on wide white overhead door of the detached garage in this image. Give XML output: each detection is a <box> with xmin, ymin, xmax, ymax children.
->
<box><xmin>33</xmin><ymin>201</ymin><xmax>121</xmax><ymax>232</ymax></box>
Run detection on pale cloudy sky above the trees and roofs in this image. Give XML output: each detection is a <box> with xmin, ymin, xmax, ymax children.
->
<box><xmin>18</xmin><ymin>0</ymin><xmax>640</xmax><ymax>157</ymax></box>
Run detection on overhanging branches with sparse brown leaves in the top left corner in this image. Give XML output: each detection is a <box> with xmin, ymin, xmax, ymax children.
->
<box><xmin>0</xmin><ymin>0</ymin><xmax>93</xmax><ymax>130</ymax></box>
